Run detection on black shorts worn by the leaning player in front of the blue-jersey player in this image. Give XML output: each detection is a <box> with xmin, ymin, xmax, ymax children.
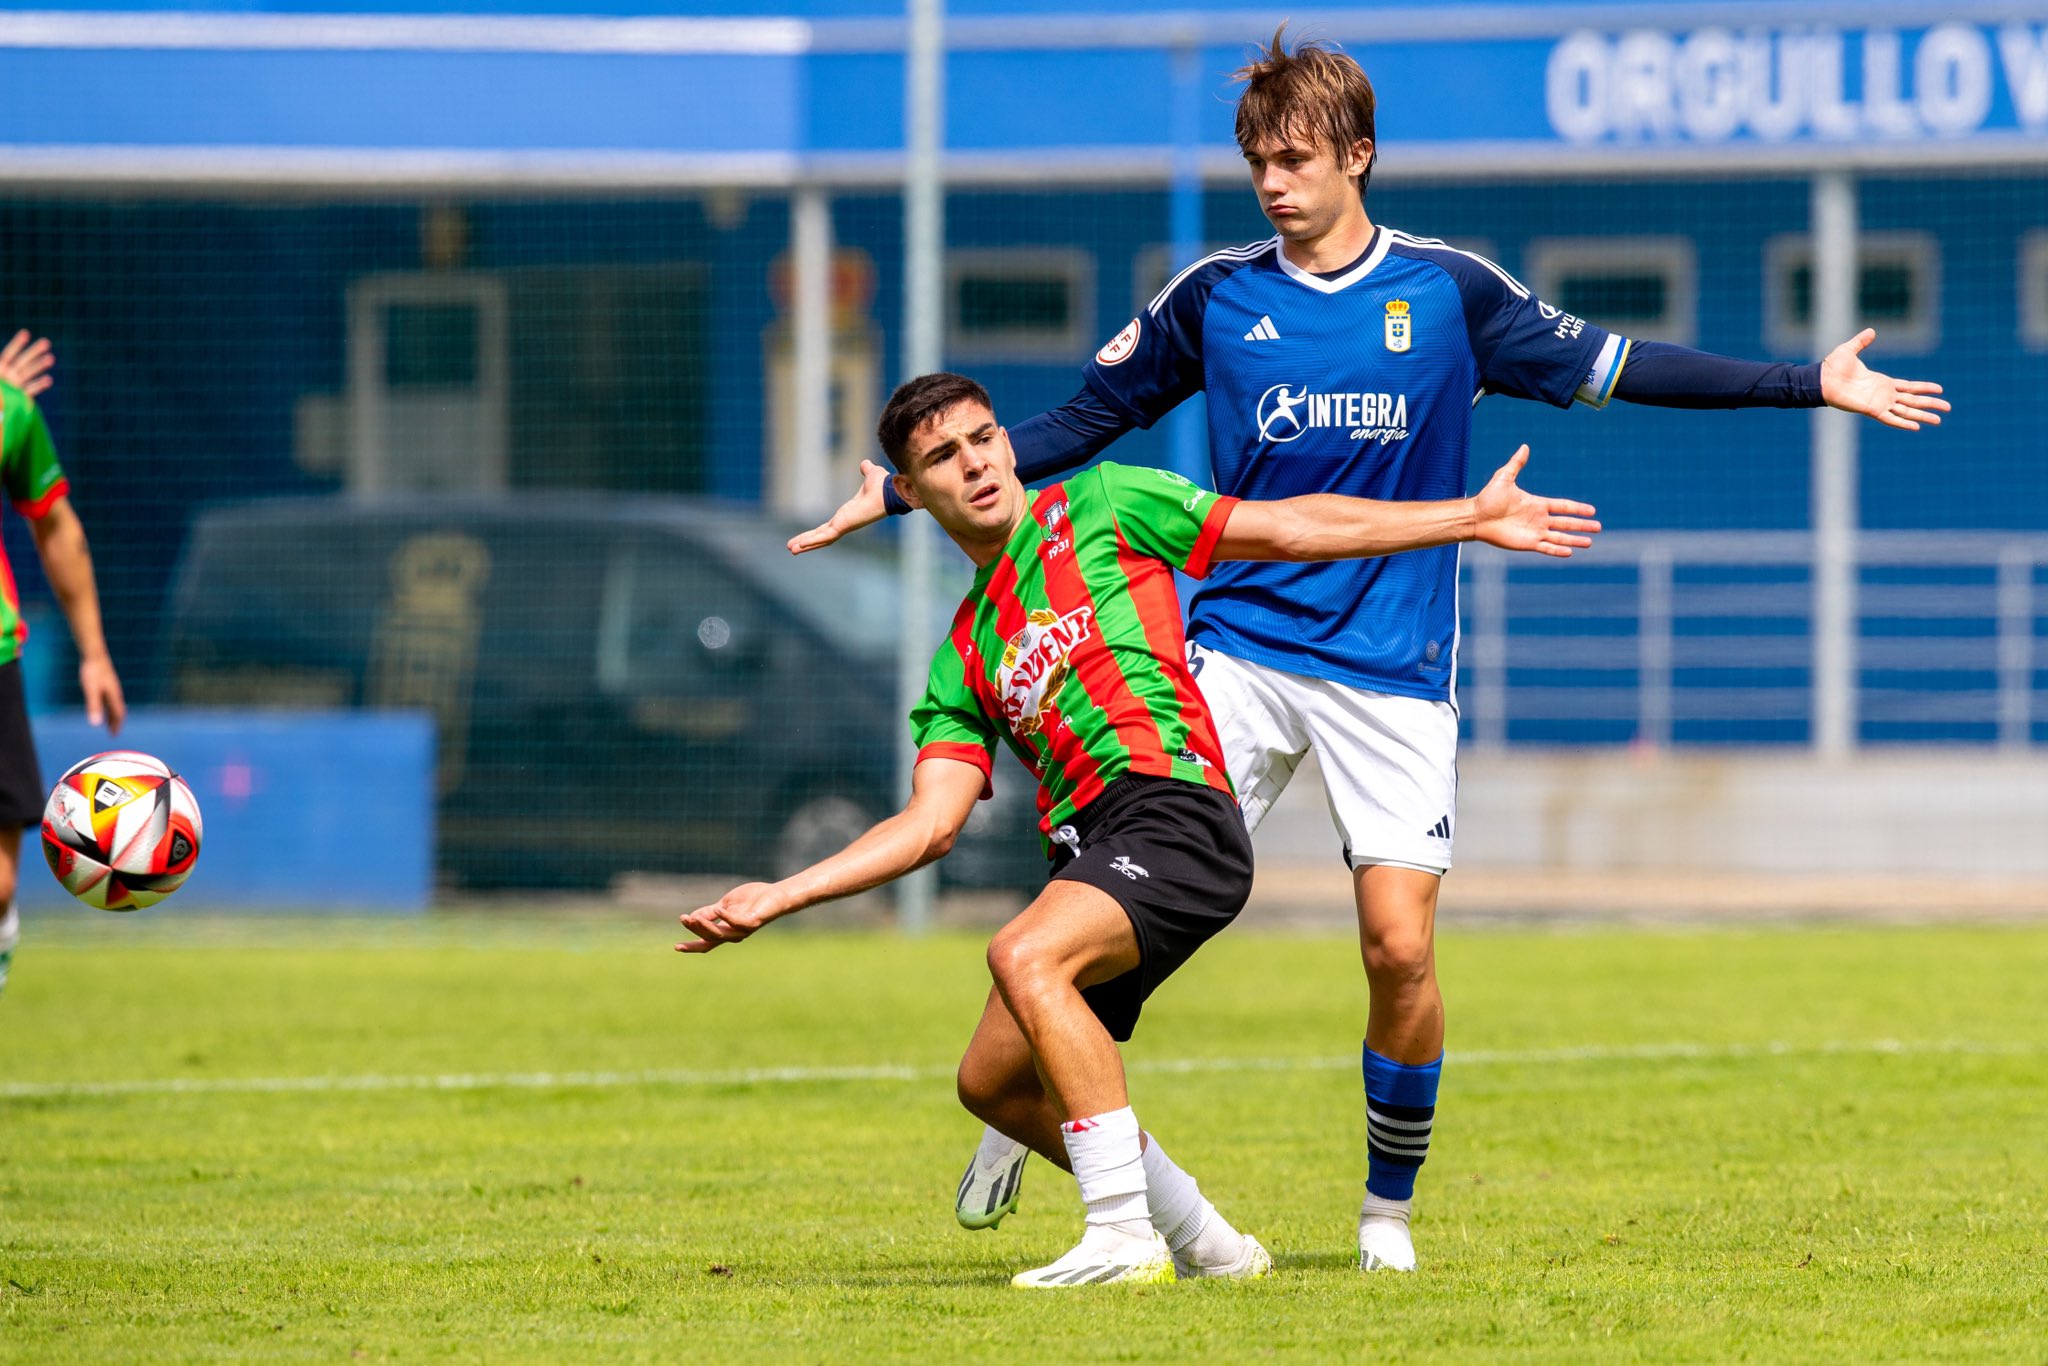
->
<box><xmin>1051</xmin><ymin>774</ymin><xmax>1251</xmax><ymax>1042</ymax></box>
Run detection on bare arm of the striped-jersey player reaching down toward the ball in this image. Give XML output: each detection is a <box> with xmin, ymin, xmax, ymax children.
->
<box><xmin>676</xmin><ymin>758</ymin><xmax>987</xmax><ymax>954</ymax></box>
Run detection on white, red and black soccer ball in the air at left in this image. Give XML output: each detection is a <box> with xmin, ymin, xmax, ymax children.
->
<box><xmin>43</xmin><ymin>750</ymin><xmax>201</xmax><ymax>911</ymax></box>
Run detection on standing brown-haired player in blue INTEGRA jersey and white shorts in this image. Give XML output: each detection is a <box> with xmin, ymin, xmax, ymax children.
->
<box><xmin>791</xmin><ymin>29</ymin><xmax>1948</xmax><ymax>1270</ymax></box>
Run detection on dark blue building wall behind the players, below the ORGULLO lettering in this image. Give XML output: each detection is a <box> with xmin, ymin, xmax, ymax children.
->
<box><xmin>0</xmin><ymin>176</ymin><xmax>2048</xmax><ymax>716</ymax></box>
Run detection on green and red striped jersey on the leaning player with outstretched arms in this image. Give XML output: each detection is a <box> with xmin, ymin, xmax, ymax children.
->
<box><xmin>909</xmin><ymin>463</ymin><xmax>1237</xmax><ymax>834</ymax></box>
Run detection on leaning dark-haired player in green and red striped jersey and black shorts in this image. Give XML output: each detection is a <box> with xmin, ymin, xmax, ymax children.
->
<box><xmin>678</xmin><ymin>375</ymin><xmax>1599</xmax><ymax>1288</ymax></box>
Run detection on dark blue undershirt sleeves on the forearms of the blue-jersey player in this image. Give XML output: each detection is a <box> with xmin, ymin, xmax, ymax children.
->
<box><xmin>883</xmin><ymin>342</ymin><xmax>1821</xmax><ymax>516</ymax></box>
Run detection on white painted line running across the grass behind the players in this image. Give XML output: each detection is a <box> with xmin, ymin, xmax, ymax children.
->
<box><xmin>0</xmin><ymin>1038</ymin><xmax>2048</xmax><ymax>1100</ymax></box>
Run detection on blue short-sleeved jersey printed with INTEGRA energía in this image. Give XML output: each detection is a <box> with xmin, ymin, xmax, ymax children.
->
<box><xmin>1087</xmin><ymin>227</ymin><xmax>1628</xmax><ymax>700</ymax></box>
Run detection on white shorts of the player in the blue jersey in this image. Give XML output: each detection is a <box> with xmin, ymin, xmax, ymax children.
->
<box><xmin>1188</xmin><ymin>641</ymin><xmax>1458</xmax><ymax>872</ymax></box>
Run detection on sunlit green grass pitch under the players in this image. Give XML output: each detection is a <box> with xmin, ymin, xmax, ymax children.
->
<box><xmin>0</xmin><ymin>907</ymin><xmax>2048</xmax><ymax>1364</ymax></box>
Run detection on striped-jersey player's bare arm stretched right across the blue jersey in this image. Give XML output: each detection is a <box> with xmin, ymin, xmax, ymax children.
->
<box><xmin>1214</xmin><ymin>446</ymin><xmax>1599</xmax><ymax>561</ymax></box>
